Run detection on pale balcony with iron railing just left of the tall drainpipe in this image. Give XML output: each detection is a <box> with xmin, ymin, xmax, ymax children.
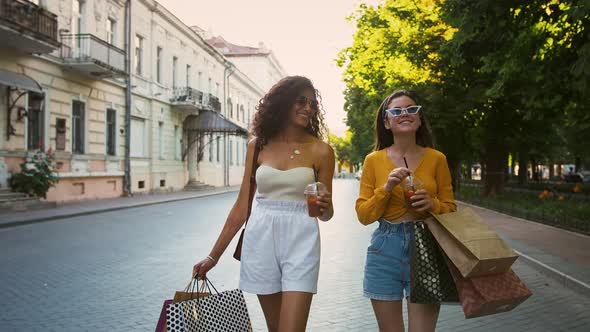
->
<box><xmin>60</xmin><ymin>34</ymin><xmax>126</xmax><ymax>79</ymax></box>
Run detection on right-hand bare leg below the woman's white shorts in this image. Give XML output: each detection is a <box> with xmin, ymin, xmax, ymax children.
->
<box><xmin>279</xmin><ymin>292</ymin><xmax>313</xmax><ymax>332</ymax></box>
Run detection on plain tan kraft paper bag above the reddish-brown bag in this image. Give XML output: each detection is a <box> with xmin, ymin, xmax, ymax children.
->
<box><xmin>425</xmin><ymin>208</ymin><xmax>518</xmax><ymax>278</ymax></box>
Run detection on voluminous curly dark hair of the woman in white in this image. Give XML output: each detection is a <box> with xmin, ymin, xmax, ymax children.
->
<box><xmin>252</xmin><ymin>76</ymin><xmax>326</xmax><ymax>146</ymax></box>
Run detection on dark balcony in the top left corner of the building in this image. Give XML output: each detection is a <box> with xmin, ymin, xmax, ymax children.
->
<box><xmin>0</xmin><ymin>0</ymin><xmax>59</xmax><ymax>54</ymax></box>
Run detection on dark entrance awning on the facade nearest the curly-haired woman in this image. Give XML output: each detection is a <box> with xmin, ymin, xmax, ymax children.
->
<box><xmin>184</xmin><ymin>111</ymin><xmax>248</xmax><ymax>135</ymax></box>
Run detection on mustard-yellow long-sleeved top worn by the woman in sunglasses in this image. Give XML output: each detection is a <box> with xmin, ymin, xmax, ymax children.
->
<box><xmin>356</xmin><ymin>148</ymin><xmax>457</xmax><ymax>225</ymax></box>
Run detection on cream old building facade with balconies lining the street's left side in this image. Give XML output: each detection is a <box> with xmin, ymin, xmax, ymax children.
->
<box><xmin>0</xmin><ymin>0</ymin><xmax>284</xmax><ymax>202</ymax></box>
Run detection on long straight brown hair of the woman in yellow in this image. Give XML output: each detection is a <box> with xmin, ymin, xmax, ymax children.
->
<box><xmin>373</xmin><ymin>90</ymin><xmax>434</xmax><ymax>151</ymax></box>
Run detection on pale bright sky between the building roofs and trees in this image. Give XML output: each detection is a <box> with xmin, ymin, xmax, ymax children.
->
<box><xmin>157</xmin><ymin>0</ymin><xmax>377</xmax><ymax>136</ymax></box>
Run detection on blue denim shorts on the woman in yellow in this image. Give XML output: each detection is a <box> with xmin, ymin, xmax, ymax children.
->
<box><xmin>363</xmin><ymin>220</ymin><xmax>412</xmax><ymax>301</ymax></box>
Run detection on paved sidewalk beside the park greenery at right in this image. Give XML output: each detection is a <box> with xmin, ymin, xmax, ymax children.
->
<box><xmin>458</xmin><ymin>202</ymin><xmax>590</xmax><ymax>296</ymax></box>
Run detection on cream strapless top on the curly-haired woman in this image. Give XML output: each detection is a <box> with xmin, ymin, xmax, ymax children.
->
<box><xmin>256</xmin><ymin>165</ymin><xmax>315</xmax><ymax>201</ymax></box>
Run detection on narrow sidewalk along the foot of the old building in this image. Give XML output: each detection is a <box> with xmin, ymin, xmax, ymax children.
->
<box><xmin>0</xmin><ymin>186</ymin><xmax>240</xmax><ymax>228</ymax></box>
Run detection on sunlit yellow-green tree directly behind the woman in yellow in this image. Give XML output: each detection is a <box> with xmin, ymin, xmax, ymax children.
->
<box><xmin>337</xmin><ymin>0</ymin><xmax>463</xmax><ymax>170</ymax></box>
